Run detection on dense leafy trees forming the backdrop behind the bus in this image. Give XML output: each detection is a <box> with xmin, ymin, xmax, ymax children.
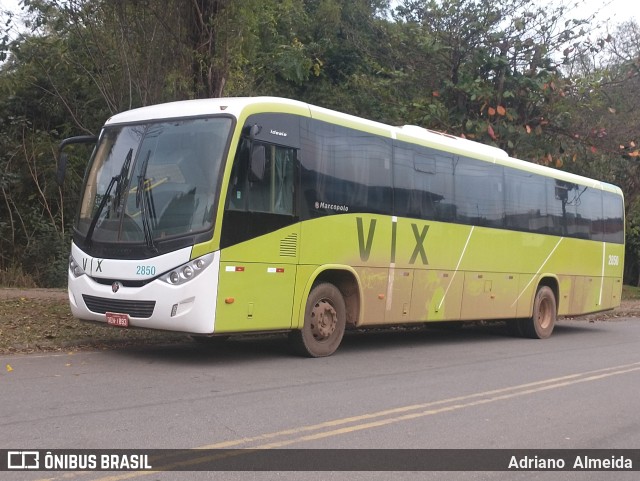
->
<box><xmin>0</xmin><ymin>0</ymin><xmax>640</xmax><ymax>285</ymax></box>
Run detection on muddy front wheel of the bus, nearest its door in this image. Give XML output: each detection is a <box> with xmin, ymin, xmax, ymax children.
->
<box><xmin>289</xmin><ymin>283</ymin><xmax>347</xmax><ymax>357</ymax></box>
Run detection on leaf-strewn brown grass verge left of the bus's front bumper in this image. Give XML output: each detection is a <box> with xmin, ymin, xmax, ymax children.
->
<box><xmin>0</xmin><ymin>297</ymin><xmax>187</xmax><ymax>354</ymax></box>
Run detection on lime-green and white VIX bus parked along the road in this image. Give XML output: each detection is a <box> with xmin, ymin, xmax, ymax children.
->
<box><xmin>60</xmin><ymin>97</ymin><xmax>625</xmax><ymax>357</ymax></box>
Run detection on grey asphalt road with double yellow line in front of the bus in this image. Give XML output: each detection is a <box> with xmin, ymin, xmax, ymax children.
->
<box><xmin>0</xmin><ymin>319</ymin><xmax>640</xmax><ymax>481</ymax></box>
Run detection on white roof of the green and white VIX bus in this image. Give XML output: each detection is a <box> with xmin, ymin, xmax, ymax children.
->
<box><xmin>105</xmin><ymin>97</ymin><xmax>622</xmax><ymax>194</ymax></box>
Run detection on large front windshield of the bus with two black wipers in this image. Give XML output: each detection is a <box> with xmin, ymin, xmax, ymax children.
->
<box><xmin>76</xmin><ymin>117</ymin><xmax>232</xmax><ymax>247</ymax></box>
